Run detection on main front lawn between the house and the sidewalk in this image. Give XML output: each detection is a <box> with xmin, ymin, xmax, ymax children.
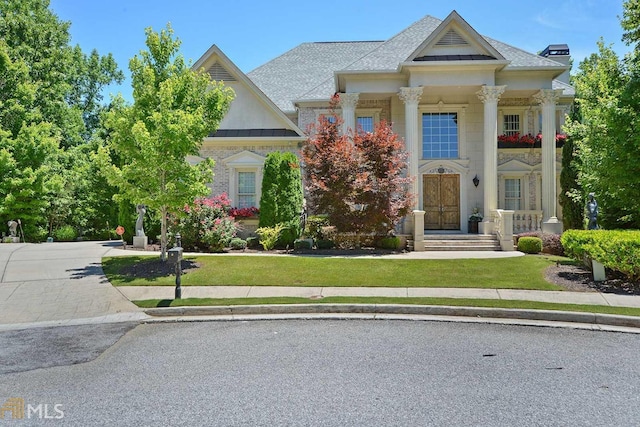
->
<box><xmin>103</xmin><ymin>255</ymin><xmax>564</xmax><ymax>290</ymax></box>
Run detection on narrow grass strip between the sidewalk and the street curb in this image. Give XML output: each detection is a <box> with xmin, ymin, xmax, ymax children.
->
<box><xmin>134</xmin><ymin>297</ymin><xmax>640</xmax><ymax>316</ymax></box>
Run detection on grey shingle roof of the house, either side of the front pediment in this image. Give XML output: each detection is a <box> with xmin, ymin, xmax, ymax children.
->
<box><xmin>247</xmin><ymin>15</ymin><xmax>570</xmax><ymax>112</ymax></box>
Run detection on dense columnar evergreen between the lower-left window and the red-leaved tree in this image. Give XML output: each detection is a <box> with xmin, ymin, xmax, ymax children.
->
<box><xmin>259</xmin><ymin>151</ymin><xmax>303</xmax><ymax>245</ymax></box>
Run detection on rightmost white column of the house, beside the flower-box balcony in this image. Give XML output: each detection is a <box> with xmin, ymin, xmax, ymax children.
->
<box><xmin>533</xmin><ymin>89</ymin><xmax>562</xmax><ymax>234</ymax></box>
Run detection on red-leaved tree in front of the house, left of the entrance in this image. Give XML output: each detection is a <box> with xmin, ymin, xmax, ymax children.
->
<box><xmin>302</xmin><ymin>99</ymin><xmax>413</xmax><ymax>234</ymax></box>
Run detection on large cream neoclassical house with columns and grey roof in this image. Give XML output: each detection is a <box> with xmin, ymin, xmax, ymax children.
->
<box><xmin>194</xmin><ymin>11</ymin><xmax>575</xmax><ymax>247</ymax></box>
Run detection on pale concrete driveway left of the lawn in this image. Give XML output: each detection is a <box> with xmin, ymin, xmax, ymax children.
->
<box><xmin>0</xmin><ymin>241</ymin><xmax>146</xmax><ymax>330</ymax></box>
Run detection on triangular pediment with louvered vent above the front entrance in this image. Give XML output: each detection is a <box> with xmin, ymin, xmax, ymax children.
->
<box><xmin>407</xmin><ymin>11</ymin><xmax>504</xmax><ymax>62</ymax></box>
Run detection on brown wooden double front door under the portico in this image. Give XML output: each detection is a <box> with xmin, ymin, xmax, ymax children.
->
<box><xmin>422</xmin><ymin>174</ymin><xmax>460</xmax><ymax>230</ymax></box>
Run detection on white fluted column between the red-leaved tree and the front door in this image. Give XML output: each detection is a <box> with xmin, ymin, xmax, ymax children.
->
<box><xmin>399</xmin><ymin>87</ymin><xmax>422</xmax><ymax>210</ymax></box>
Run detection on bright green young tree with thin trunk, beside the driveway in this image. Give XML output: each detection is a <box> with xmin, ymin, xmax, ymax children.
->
<box><xmin>98</xmin><ymin>25</ymin><xmax>233</xmax><ymax>260</ymax></box>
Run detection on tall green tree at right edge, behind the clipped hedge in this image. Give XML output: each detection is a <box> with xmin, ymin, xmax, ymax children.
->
<box><xmin>567</xmin><ymin>41</ymin><xmax>640</xmax><ymax>228</ymax></box>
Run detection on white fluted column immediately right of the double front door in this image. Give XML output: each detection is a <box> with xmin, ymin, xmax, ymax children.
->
<box><xmin>476</xmin><ymin>86</ymin><xmax>506</xmax><ymax>234</ymax></box>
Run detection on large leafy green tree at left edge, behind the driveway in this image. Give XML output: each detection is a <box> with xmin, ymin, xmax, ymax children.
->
<box><xmin>0</xmin><ymin>0</ymin><xmax>123</xmax><ymax>239</ymax></box>
